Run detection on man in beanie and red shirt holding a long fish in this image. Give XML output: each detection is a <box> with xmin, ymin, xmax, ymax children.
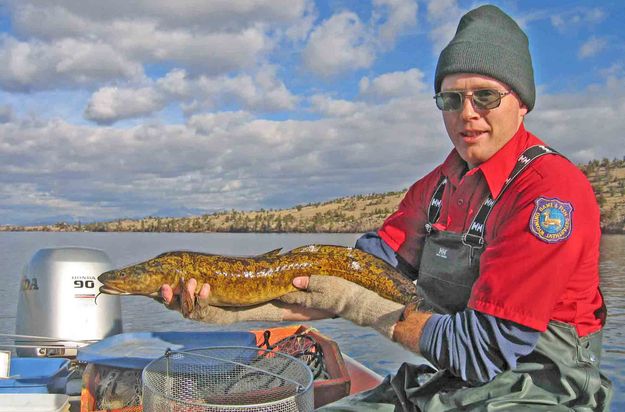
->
<box><xmin>162</xmin><ymin>6</ymin><xmax>611</xmax><ymax>411</ymax></box>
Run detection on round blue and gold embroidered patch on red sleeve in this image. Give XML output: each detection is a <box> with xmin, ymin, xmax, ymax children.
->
<box><xmin>530</xmin><ymin>197</ymin><xmax>573</xmax><ymax>243</ymax></box>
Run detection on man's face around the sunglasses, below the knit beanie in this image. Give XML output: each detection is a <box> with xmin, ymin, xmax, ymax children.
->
<box><xmin>441</xmin><ymin>73</ymin><xmax>527</xmax><ymax>168</ymax></box>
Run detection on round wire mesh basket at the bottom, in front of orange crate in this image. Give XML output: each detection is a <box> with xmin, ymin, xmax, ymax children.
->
<box><xmin>142</xmin><ymin>347</ymin><xmax>314</xmax><ymax>412</ymax></box>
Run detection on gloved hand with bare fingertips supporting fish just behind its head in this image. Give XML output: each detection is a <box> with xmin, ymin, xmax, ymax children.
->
<box><xmin>160</xmin><ymin>279</ymin><xmax>331</xmax><ymax>324</ymax></box>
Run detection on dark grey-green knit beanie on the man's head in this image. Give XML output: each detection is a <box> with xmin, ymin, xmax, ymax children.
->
<box><xmin>434</xmin><ymin>5</ymin><xmax>536</xmax><ymax>112</ymax></box>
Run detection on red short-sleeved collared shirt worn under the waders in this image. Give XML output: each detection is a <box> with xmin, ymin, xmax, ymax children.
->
<box><xmin>378</xmin><ymin>125</ymin><xmax>603</xmax><ymax>336</ymax></box>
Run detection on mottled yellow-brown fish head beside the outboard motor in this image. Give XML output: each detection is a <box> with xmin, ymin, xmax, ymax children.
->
<box><xmin>98</xmin><ymin>253</ymin><xmax>183</xmax><ymax>296</ymax></box>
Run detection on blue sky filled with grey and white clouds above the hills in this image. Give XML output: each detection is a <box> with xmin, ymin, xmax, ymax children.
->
<box><xmin>0</xmin><ymin>0</ymin><xmax>625</xmax><ymax>225</ymax></box>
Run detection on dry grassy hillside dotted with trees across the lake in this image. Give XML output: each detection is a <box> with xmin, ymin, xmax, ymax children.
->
<box><xmin>0</xmin><ymin>158</ymin><xmax>625</xmax><ymax>233</ymax></box>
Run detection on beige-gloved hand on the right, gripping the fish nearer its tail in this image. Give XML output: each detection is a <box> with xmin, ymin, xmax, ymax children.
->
<box><xmin>279</xmin><ymin>276</ymin><xmax>404</xmax><ymax>339</ymax></box>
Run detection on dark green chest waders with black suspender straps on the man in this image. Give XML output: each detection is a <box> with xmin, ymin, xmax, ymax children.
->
<box><xmin>323</xmin><ymin>146</ymin><xmax>612</xmax><ymax>411</ymax></box>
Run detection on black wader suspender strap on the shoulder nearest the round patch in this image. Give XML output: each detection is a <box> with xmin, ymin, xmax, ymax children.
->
<box><xmin>462</xmin><ymin>145</ymin><xmax>562</xmax><ymax>248</ymax></box>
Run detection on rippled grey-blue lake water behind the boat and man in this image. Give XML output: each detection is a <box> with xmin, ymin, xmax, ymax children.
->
<box><xmin>0</xmin><ymin>232</ymin><xmax>625</xmax><ymax>411</ymax></box>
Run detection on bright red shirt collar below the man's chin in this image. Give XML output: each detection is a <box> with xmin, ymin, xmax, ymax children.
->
<box><xmin>441</xmin><ymin>123</ymin><xmax>541</xmax><ymax>199</ymax></box>
